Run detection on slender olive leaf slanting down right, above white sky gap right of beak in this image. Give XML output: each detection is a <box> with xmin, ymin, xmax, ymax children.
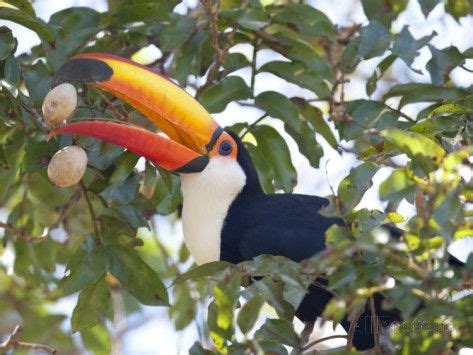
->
<box><xmin>259</xmin><ymin>61</ymin><xmax>330</xmax><ymax>97</ymax></box>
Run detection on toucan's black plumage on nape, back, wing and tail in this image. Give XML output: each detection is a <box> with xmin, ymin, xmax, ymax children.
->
<box><xmin>220</xmin><ymin>132</ymin><xmax>401</xmax><ymax>350</ymax></box>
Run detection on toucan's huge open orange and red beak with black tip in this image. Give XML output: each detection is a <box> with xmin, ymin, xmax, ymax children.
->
<box><xmin>52</xmin><ymin>53</ymin><xmax>223</xmax><ymax>173</ymax></box>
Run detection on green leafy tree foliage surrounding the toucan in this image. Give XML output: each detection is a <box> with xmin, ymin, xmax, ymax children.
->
<box><xmin>0</xmin><ymin>0</ymin><xmax>473</xmax><ymax>354</ymax></box>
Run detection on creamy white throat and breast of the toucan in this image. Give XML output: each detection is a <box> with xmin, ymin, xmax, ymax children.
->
<box><xmin>181</xmin><ymin>157</ymin><xmax>246</xmax><ymax>264</ymax></box>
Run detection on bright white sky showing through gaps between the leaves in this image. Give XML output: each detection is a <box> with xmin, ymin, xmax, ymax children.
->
<box><xmin>0</xmin><ymin>0</ymin><xmax>473</xmax><ymax>354</ymax></box>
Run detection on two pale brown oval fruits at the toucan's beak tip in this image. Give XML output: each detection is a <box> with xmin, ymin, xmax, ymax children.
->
<box><xmin>42</xmin><ymin>83</ymin><xmax>87</xmax><ymax>187</ymax></box>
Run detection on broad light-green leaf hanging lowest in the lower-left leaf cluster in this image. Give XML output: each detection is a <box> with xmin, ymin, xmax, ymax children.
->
<box><xmin>71</xmin><ymin>277</ymin><xmax>110</xmax><ymax>332</ymax></box>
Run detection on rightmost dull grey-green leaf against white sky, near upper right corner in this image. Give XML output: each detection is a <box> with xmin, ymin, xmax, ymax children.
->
<box><xmin>427</xmin><ymin>45</ymin><xmax>465</xmax><ymax>85</ymax></box>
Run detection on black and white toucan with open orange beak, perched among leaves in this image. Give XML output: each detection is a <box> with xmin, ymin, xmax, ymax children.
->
<box><xmin>48</xmin><ymin>54</ymin><xmax>458</xmax><ymax>350</ymax></box>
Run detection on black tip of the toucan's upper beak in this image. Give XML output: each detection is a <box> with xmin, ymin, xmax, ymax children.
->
<box><xmin>51</xmin><ymin>58</ymin><xmax>113</xmax><ymax>88</ymax></box>
